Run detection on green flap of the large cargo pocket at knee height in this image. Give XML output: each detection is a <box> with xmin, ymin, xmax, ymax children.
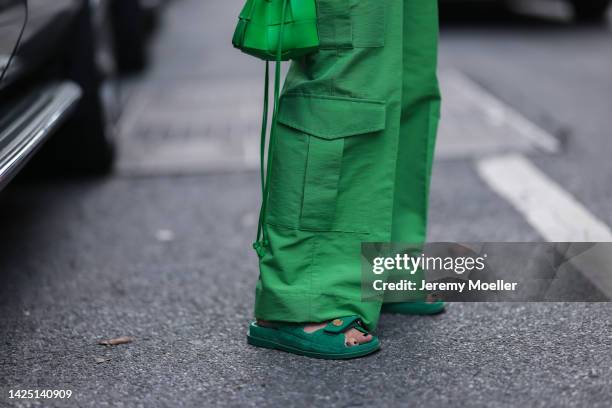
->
<box><xmin>278</xmin><ymin>95</ymin><xmax>386</xmax><ymax>139</ymax></box>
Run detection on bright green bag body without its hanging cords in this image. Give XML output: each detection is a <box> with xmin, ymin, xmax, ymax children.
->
<box><xmin>232</xmin><ymin>0</ymin><xmax>319</xmax><ymax>61</ymax></box>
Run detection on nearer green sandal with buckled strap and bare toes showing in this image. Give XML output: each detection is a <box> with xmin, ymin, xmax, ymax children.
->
<box><xmin>247</xmin><ymin>316</ymin><xmax>380</xmax><ymax>360</ymax></box>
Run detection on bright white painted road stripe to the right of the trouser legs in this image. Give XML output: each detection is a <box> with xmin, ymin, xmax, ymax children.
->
<box><xmin>476</xmin><ymin>154</ymin><xmax>612</xmax><ymax>298</ymax></box>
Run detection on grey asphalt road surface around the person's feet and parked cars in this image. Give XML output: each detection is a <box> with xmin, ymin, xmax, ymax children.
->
<box><xmin>0</xmin><ymin>0</ymin><xmax>612</xmax><ymax>407</ymax></box>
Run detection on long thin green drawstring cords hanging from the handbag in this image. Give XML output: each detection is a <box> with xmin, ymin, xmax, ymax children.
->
<box><xmin>253</xmin><ymin>0</ymin><xmax>289</xmax><ymax>259</ymax></box>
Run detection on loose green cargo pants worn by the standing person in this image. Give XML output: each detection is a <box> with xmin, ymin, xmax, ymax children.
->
<box><xmin>255</xmin><ymin>0</ymin><xmax>440</xmax><ymax>329</ymax></box>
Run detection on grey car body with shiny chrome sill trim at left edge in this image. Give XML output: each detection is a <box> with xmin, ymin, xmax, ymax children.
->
<box><xmin>0</xmin><ymin>0</ymin><xmax>83</xmax><ymax>187</ymax></box>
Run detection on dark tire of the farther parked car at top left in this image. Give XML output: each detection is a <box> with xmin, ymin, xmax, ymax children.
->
<box><xmin>111</xmin><ymin>0</ymin><xmax>148</xmax><ymax>73</ymax></box>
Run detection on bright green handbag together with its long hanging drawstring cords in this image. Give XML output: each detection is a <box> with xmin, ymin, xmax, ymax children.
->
<box><xmin>232</xmin><ymin>0</ymin><xmax>319</xmax><ymax>258</ymax></box>
